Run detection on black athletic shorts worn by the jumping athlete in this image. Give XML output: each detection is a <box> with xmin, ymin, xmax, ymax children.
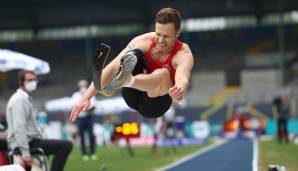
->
<box><xmin>122</xmin><ymin>50</ymin><xmax>172</xmax><ymax>118</ymax></box>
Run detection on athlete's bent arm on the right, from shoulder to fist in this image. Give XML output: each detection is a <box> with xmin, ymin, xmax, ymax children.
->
<box><xmin>169</xmin><ymin>45</ymin><xmax>194</xmax><ymax>102</ymax></box>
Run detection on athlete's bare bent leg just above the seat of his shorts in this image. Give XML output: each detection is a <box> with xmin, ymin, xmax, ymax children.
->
<box><xmin>132</xmin><ymin>68</ymin><xmax>173</xmax><ymax>97</ymax></box>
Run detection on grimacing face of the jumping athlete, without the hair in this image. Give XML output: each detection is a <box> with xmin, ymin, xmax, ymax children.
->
<box><xmin>155</xmin><ymin>23</ymin><xmax>180</xmax><ymax>51</ymax></box>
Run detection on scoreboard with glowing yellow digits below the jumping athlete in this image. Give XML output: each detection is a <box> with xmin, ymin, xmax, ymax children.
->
<box><xmin>111</xmin><ymin>122</ymin><xmax>140</xmax><ymax>141</ymax></box>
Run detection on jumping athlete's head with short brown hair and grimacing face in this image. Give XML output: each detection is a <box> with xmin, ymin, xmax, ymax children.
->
<box><xmin>155</xmin><ymin>8</ymin><xmax>181</xmax><ymax>50</ymax></box>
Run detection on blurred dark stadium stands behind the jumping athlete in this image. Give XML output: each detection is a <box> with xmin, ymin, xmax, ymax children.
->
<box><xmin>0</xmin><ymin>0</ymin><xmax>298</xmax><ymax>138</ymax></box>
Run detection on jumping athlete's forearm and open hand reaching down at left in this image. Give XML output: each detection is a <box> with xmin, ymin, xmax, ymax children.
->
<box><xmin>70</xmin><ymin>82</ymin><xmax>96</xmax><ymax>122</ymax></box>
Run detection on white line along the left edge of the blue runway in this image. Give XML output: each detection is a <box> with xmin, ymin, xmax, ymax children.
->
<box><xmin>156</xmin><ymin>140</ymin><xmax>227</xmax><ymax>171</ymax></box>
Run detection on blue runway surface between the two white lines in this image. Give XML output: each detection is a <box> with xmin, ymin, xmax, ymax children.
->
<box><xmin>159</xmin><ymin>138</ymin><xmax>254</xmax><ymax>171</ymax></box>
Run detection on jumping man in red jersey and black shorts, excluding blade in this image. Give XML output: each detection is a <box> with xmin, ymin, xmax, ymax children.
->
<box><xmin>70</xmin><ymin>8</ymin><xmax>193</xmax><ymax>121</ymax></box>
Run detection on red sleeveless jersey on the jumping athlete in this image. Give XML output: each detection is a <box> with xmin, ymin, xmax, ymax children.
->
<box><xmin>144</xmin><ymin>38</ymin><xmax>183</xmax><ymax>84</ymax></box>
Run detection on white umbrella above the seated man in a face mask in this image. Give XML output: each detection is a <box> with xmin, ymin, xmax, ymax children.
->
<box><xmin>0</xmin><ymin>49</ymin><xmax>50</xmax><ymax>74</ymax></box>
